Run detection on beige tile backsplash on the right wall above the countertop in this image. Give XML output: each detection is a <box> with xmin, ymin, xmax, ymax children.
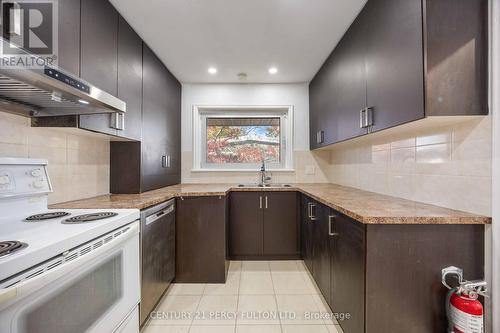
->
<box><xmin>325</xmin><ymin>117</ymin><xmax>492</xmax><ymax>215</ymax></box>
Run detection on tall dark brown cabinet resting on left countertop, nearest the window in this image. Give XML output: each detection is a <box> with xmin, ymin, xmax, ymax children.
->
<box><xmin>110</xmin><ymin>44</ymin><xmax>181</xmax><ymax>193</ymax></box>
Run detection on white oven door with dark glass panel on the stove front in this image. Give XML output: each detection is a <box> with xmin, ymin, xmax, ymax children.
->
<box><xmin>0</xmin><ymin>222</ymin><xmax>140</xmax><ymax>333</ymax></box>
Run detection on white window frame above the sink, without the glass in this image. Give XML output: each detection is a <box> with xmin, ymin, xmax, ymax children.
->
<box><xmin>192</xmin><ymin>105</ymin><xmax>293</xmax><ymax>171</ymax></box>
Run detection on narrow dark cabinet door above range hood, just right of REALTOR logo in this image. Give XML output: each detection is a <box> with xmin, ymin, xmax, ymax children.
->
<box><xmin>56</xmin><ymin>0</ymin><xmax>80</xmax><ymax>76</ymax></box>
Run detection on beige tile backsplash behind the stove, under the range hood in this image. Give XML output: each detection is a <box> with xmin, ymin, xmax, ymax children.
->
<box><xmin>0</xmin><ymin>112</ymin><xmax>109</xmax><ymax>203</ymax></box>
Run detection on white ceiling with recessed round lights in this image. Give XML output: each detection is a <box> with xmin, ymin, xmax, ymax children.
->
<box><xmin>111</xmin><ymin>0</ymin><xmax>366</xmax><ymax>83</ymax></box>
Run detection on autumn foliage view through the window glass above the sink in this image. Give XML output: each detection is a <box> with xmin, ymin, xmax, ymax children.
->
<box><xmin>206</xmin><ymin>117</ymin><xmax>281</xmax><ymax>164</ymax></box>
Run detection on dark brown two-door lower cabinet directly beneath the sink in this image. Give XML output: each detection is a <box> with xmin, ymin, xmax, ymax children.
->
<box><xmin>229</xmin><ymin>191</ymin><xmax>300</xmax><ymax>260</ymax></box>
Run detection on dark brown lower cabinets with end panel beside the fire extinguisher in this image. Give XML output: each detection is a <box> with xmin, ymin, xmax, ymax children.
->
<box><xmin>301</xmin><ymin>196</ymin><xmax>484</xmax><ymax>333</ymax></box>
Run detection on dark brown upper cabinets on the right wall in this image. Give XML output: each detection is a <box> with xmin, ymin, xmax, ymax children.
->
<box><xmin>309</xmin><ymin>0</ymin><xmax>488</xmax><ymax>149</ymax></box>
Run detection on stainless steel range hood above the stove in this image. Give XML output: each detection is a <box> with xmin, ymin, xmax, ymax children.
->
<box><xmin>0</xmin><ymin>39</ymin><xmax>126</xmax><ymax>117</ymax></box>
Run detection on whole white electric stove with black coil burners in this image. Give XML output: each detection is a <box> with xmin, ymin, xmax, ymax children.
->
<box><xmin>0</xmin><ymin>158</ymin><xmax>140</xmax><ymax>333</ymax></box>
